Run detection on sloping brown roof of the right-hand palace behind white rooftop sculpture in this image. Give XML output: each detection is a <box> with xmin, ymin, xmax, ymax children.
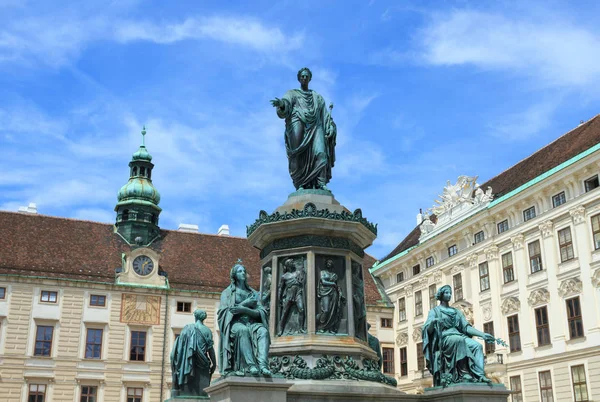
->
<box><xmin>381</xmin><ymin>115</ymin><xmax>600</xmax><ymax>262</ymax></box>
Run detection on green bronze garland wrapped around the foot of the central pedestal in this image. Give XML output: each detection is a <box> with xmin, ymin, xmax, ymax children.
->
<box><xmin>269</xmin><ymin>356</ymin><xmax>397</xmax><ymax>387</ymax></box>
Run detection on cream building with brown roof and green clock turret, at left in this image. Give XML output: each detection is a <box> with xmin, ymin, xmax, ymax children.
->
<box><xmin>0</xmin><ymin>131</ymin><xmax>394</xmax><ymax>402</ymax></box>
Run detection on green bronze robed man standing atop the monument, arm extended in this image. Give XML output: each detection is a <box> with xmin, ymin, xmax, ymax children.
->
<box><xmin>271</xmin><ymin>67</ymin><xmax>337</xmax><ymax>190</ymax></box>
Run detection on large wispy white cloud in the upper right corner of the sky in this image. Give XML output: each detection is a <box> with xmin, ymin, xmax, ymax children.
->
<box><xmin>418</xmin><ymin>10</ymin><xmax>600</xmax><ymax>86</ymax></box>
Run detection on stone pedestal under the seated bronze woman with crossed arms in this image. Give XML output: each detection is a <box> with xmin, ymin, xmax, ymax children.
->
<box><xmin>205</xmin><ymin>377</ymin><xmax>292</xmax><ymax>402</ymax></box>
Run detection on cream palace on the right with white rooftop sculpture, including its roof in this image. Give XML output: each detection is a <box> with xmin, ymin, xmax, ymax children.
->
<box><xmin>371</xmin><ymin>116</ymin><xmax>600</xmax><ymax>402</ymax></box>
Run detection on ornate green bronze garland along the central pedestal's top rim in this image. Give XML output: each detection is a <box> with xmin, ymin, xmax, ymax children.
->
<box><xmin>246</xmin><ymin>202</ymin><xmax>377</xmax><ymax>236</ymax></box>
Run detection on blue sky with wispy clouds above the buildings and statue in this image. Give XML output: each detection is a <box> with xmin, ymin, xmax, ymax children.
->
<box><xmin>0</xmin><ymin>0</ymin><xmax>600</xmax><ymax>257</ymax></box>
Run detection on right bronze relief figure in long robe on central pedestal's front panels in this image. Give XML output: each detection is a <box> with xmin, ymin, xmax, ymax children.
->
<box><xmin>316</xmin><ymin>258</ymin><xmax>346</xmax><ymax>334</ymax></box>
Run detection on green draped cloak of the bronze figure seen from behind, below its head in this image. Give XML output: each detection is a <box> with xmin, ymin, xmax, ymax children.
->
<box><xmin>171</xmin><ymin>324</ymin><xmax>213</xmax><ymax>389</ymax></box>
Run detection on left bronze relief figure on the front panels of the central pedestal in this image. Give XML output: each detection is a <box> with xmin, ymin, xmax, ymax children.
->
<box><xmin>278</xmin><ymin>258</ymin><xmax>306</xmax><ymax>336</ymax></box>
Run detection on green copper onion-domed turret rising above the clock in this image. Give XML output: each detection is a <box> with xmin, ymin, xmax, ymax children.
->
<box><xmin>115</xmin><ymin>127</ymin><xmax>161</xmax><ymax>246</ymax></box>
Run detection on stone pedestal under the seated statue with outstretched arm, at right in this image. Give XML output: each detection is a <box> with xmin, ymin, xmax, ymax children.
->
<box><xmin>422</xmin><ymin>384</ymin><xmax>510</xmax><ymax>402</ymax></box>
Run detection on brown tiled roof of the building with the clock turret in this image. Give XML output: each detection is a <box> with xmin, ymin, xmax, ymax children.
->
<box><xmin>0</xmin><ymin>211</ymin><xmax>385</xmax><ymax>305</ymax></box>
